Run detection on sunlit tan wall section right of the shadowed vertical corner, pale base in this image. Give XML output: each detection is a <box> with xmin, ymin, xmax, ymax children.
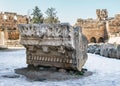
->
<box><xmin>108</xmin><ymin>14</ymin><xmax>120</xmax><ymax>44</ymax></box>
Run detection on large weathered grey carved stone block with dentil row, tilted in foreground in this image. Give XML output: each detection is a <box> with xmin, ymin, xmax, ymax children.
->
<box><xmin>18</xmin><ymin>23</ymin><xmax>87</xmax><ymax>71</ymax></box>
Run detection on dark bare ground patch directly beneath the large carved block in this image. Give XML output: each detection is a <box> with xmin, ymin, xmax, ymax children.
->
<box><xmin>15</xmin><ymin>67</ymin><xmax>92</xmax><ymax>81</ymax></box>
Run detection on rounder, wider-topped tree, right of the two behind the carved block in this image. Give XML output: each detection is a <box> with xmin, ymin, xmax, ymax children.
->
<box><xmin>44</xmin><ymin>7</ymin><xmax>60</xmax><ymax>23</ymax></box>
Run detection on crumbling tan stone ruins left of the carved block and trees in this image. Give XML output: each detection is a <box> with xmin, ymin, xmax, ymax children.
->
<box><xmin>0</xmin><ymin>12</ymin><xmax>28</xmax><ymax>47</ymax></box>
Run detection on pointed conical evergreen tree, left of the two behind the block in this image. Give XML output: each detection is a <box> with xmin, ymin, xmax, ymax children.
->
<box><xmin>31</xmin><ymin>6</ymin><xmax>44</xmax><ymax>23</ymax></box>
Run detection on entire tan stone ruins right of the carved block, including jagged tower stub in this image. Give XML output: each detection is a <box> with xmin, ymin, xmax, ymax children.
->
<box><xmin>75</xmin><ymin>9</ymin><xmax>120</xmax><ymax>43</ymax></box>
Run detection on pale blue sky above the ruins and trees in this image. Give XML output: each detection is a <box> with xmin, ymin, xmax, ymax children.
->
<box><xmin>0</xmin><ymin>0</ymin><xmax>120</xmax><ymax>25</ymax></box>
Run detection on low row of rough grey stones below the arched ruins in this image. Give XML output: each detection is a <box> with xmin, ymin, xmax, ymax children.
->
<box><xmin>87</xmin><ymin>44</ymin><xmax>120</xmax><ymax>59</ymax></box>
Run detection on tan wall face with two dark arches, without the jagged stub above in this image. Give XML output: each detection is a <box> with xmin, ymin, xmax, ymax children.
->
<box><xmin>77</xmin><ymin>19</ymin><xmax>105</xmax><ymax>43</ymax></box>
